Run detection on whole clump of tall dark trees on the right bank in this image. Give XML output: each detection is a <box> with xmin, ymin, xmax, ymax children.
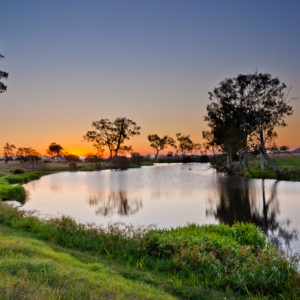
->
<box><xmin>205</xmin><ymin>73</ymin><xmax>292</xmax><ymax>177</ymax></box>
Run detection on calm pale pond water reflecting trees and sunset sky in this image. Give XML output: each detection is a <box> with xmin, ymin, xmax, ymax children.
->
<box><xmin>23</xmin><ymin>163</ymin><xmax>300</xmax><ymax>253</ymax></box>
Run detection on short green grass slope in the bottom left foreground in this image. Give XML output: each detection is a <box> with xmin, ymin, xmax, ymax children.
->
<box><xmin>0</xmin><ymin>226</ymin><xmax>174</xmax><ymax>299</ymax></box>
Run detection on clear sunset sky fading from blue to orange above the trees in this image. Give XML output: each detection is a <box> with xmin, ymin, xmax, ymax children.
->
<box><xmin>0</xmin><ymin>0</ymin><xmax>300</xmax><ymax>155</ymax></box>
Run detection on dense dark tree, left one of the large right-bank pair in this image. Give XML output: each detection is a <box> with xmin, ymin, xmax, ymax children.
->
<box><xmin>203</xmin><ymin>75</ymin><xmax>254</xmax><ymax>172</ymax></box>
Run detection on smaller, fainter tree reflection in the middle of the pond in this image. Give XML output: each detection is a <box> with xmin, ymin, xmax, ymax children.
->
<box><xmin>89</xmin><ymin>191</ymin><xmax>143</xmax><ymax>216</ymax></box>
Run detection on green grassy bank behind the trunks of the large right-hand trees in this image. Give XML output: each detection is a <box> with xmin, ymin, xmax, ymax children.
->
<box><xmin>244</xmin><ymin>157</ymin><xmax>300</xmax><ymax>181</ymax></box>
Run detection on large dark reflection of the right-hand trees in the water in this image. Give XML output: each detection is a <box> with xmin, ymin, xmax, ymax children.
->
<box><xmin>206</xmin><ymin>176</ymin><xmax>298</xmax><ymax>250</ymax></box>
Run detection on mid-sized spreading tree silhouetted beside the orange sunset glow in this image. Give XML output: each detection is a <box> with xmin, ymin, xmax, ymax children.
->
<box><xmin>83</xmin><ymin>117</ymin><xmax>141</xmax><ymax>158</ymax></box>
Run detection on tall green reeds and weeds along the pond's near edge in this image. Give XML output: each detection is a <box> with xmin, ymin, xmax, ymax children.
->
<box><xmin>0</xmin><ymin>204</ymin><xmax>300</xmax><ymax>299</ymax></box>
